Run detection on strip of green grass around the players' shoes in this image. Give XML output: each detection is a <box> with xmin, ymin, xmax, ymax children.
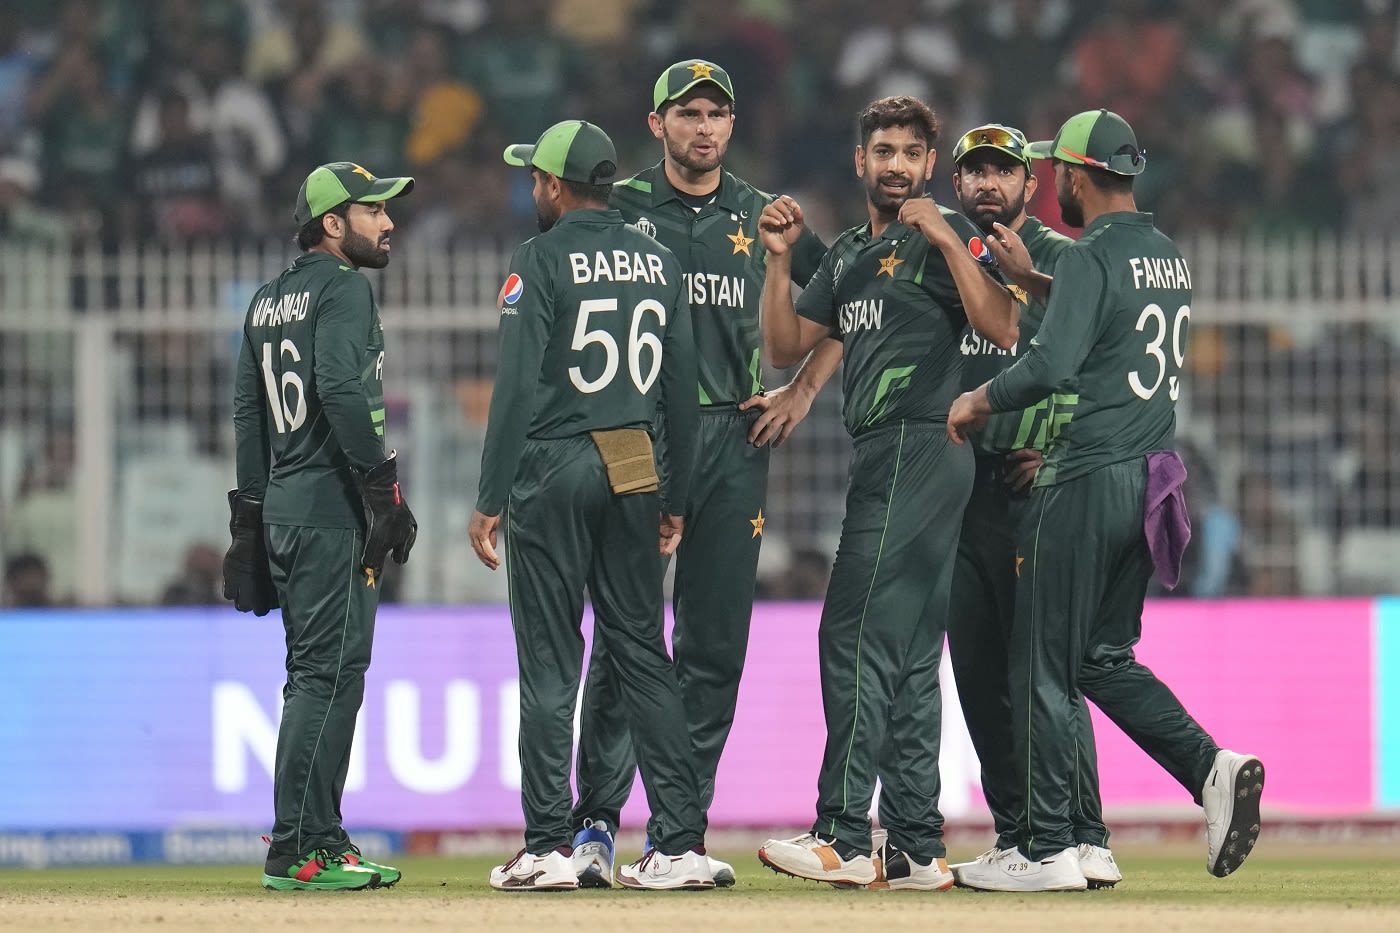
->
<box><xmin>8</xmin><ymin>843</ymin><xmax>1400</xmax><ymax>902</ymax></box>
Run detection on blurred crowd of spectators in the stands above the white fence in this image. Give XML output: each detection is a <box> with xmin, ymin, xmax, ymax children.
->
<box><xmin>0</xmin><ymin>0</ymin><xmax>1400</xmax><ymax>244</ymax></box>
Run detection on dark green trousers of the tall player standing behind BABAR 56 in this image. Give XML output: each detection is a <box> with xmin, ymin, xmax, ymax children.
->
<box><xmin>574</xmin><ymin>406</ymin><xmax>769</xmax><ymax>829</ymax></box>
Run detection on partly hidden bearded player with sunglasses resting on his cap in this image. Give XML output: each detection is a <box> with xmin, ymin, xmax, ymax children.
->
<box><xmin>948</xmin><ymin>123</ymin><xmax>1123</xmax><ymax>887</ymax></box>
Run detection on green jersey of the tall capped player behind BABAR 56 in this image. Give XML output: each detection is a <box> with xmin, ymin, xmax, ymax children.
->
<box><xmin>610</xmin><ymin>164</ymin><xmax>826</xmax><ymax>405</ymax></box>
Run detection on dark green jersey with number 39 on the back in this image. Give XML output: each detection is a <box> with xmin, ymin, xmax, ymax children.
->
<box><xmin>987</xmin><ymin>212</ymin><xmax>1191</xmax><ymax>486</ymax></box>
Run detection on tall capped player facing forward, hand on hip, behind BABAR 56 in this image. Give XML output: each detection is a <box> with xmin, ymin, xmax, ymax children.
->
<box><xmin>574</xmin><ymin>59</ymin><xmax>840</xmax><ymax>887</ymax></box>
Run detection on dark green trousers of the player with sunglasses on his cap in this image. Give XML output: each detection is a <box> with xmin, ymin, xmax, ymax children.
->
<box><xmin>948</xmin><ymin>454</ymin><xmax>1109</xmax><ymax>849</ymax></box>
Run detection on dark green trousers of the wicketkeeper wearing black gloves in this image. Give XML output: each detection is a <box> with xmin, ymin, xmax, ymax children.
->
<box><xmin>265</xmin><ymin>524</ymin><xmax>379</xmax><ymax>859</ymax></box>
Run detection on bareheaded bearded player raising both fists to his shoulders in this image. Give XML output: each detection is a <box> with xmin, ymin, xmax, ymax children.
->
<box><xmin>759</xmin><ymin>97</ymin><xmax>1016</xmax><ymax>891</ymax></box>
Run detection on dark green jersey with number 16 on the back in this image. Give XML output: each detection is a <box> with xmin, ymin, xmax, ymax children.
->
<box><xmin>234</xmin><ymin>252</ymin><xmax>385</xmax><ymax>528</ymax></box>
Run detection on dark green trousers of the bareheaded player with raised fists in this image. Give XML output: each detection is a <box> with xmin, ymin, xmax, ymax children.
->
<box><xmin>812</xmin><ymin>422</ymin><xmax>973</xmax><ymax>862</ymax></box>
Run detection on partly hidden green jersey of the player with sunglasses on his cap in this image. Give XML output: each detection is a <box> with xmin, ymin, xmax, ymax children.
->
<box><xmin>962</xmin><ymin>216</ymin><xmax>1074</xmax><ymax>454</ymax></box>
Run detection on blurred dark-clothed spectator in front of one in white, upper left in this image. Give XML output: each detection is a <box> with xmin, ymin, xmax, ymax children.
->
<box><xmin>122</xmin><ymin>88</ymin><xmax>225</xmax><ymax>241</ymax></box>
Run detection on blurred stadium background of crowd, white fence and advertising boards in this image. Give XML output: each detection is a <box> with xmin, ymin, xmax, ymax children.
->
<box><xmin>0</xmin><ymin>0</ymin><xmax>1400</xmax><ymax>863</ymax></box>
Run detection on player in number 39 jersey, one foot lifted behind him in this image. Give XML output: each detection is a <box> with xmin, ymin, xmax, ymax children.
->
<box><xmin>948</xmin><ymin>111</ymin><xmax>1264</xmax><ymax>891</ymax></box>
